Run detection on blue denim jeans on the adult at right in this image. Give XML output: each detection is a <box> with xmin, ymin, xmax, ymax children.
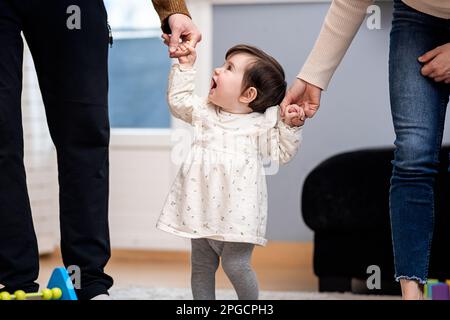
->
<box><xmin>389</xmin><ymin>0</ymin><xmax>450</xmax><ymax>283</ymax></box>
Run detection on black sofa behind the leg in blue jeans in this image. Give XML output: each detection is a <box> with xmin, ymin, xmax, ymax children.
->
<box><xmin>302</xmin><ymin>146</ymin><xmax>450</xmax><ymax>294</ymax></box>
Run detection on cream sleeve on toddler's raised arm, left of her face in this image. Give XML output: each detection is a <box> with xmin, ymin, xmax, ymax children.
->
<box><xmin>167</xmin><ymin>64</ymin><xmax>205</xmax><ymax>124</ymax></box>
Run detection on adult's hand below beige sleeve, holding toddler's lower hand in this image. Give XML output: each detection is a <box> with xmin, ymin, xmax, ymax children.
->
<box><xmin>280</xmin><ymin>78</ymin><xmax>322</xmax><ymax>118</ymax></box>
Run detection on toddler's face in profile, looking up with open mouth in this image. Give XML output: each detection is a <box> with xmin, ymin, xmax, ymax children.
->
<box><xmin>208</xmin><ymin>53</ymin><xmax>254</xmax><ymax>113</ymax></box>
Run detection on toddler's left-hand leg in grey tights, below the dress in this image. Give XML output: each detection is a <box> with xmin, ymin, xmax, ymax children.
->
<box><xmin>191</xmin><ymin>239</ymin><xmax>219</xmax><ymax>300</ymax></box>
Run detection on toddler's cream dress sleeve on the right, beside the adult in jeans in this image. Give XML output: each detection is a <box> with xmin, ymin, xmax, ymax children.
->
<box><xmin>259</xmin><ymin>106</ymin><xmax>302</xmax><ymax>164</ymax></box>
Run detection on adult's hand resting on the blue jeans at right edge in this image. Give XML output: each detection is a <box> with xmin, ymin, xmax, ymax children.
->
<box><xmin>419</xmin><ymin>42</ymin><xmax>450</xmax><ymax>83</ymax></box>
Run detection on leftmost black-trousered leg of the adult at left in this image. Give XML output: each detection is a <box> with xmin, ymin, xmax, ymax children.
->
<box><xmin>0</xmin><ymin>0</ymin><xmax>39</xmax><ymax>292</ymax></box>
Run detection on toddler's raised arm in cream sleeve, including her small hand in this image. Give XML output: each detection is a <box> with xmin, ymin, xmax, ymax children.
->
<box><xmin>163</xmin><ymin>38</ymin><xmax>204</xmax><ymax>124</ymax></box>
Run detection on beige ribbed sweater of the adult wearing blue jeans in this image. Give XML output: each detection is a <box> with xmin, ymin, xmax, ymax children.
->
<box><xmin>297</xmin><ymin>0</ymin><xmax>450</xmax><ymax>90</ymax></box>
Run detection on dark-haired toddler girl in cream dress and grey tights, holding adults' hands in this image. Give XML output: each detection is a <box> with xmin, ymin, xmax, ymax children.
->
<box><xmin>157</xmin><ymin>43</ymin><xmax>304</xmax><ymax>300</ymax></box>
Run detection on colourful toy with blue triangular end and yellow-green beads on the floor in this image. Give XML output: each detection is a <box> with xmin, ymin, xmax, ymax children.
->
<box><xmin>0</xmin><ymin>267</ymin><xmax>78</xmax><ymax>300</ymax></box>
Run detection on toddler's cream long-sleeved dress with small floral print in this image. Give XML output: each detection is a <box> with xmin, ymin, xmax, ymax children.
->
<box><xmin>157</xmin><ymin>64</ymin><xmax>302</xmax><ymax>245</ymax></box>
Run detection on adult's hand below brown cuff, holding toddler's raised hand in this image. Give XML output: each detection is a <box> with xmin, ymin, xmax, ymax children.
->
<box><xmin>163</xmin><ymin>13</ymin><xmax>202</xmax><ymax>58</ymax></box>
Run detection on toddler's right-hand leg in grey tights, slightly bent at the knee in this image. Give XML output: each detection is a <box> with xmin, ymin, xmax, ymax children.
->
<box><xmin>221</xmin><ymin>242</ymin><xmax>259</xmax><ymax>300</ymax></box>
